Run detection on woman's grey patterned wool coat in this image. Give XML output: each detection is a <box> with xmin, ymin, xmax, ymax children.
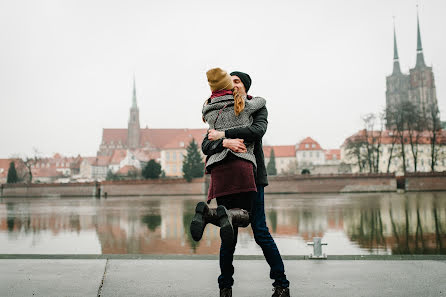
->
<box><xmin>202</xmin><ymin>95</ymin><xmax>266</xmax><ymax>169</ymax></box>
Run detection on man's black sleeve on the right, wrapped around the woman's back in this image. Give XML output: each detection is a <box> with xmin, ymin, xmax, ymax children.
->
<box><xmin>225</xmin><ymin>106</ymin><xmax>268</xmax><ymax>142</ymax></box>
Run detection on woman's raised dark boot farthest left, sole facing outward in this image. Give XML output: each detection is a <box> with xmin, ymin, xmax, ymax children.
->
<box><xmin>190</xmin><ymin>202</ymin><xmax>220</xmax><ymax>241</ymax></box>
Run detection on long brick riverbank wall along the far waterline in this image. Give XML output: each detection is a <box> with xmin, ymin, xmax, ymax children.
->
<box><xmin>0</xmin><ymin>173</ymin><xmax>446</xmax><ymax>198</ymax></box>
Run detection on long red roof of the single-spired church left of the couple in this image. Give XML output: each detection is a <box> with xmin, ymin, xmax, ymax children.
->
<box><xmin>102</xmin><ymin>128</ymin><xmax>207</xmax><ymax>149</ymax></box>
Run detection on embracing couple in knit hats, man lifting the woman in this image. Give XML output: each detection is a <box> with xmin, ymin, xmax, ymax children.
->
<box><xmin>190</xmin><ymin>68</ymin><xmax>290</xmax><ymax>297</ymax></box>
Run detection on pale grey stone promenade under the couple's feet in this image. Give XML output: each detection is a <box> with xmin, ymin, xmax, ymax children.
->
<box><xmin>0</xmin><ymin>255</ymin><xmax>446</xmax><ymax>297</ymax></box>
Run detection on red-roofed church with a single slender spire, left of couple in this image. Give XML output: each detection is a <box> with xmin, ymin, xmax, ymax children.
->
<box><xmin>97</xmin><ymin>81</ymin><xmax>207</xmax><ymax>176</ymax></box>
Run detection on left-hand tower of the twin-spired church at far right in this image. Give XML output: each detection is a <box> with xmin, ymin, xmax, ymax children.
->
<box><xmin>386</xmin><ymin>24</ymin><xmax>409</xmax><ymax>129</ymax></box>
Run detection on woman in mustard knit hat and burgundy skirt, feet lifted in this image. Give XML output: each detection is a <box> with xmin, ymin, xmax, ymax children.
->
<box><xmin>190</xmin><ymin>68</ymin><xmax>266</xmax><ymax>245</ymax></box>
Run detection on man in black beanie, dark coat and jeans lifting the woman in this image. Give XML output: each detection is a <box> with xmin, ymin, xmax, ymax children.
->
<box><xmin>201</xmin><ymin>71</ymin><xmax>290</xmax><ymax>297</ymax></box>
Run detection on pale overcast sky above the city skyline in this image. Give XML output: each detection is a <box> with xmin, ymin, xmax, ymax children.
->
<box><xmin>0</xmin><ymin>0</ymin><xmax>446</xmax><ymax>158</ymax></box>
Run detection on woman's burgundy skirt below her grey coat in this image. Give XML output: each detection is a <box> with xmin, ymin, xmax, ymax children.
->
<box><xmin>208</xmin><ymin>158</ymin><xmax>257</xmax><ymax>202</ymax></box>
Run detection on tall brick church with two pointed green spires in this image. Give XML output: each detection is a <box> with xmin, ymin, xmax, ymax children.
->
<box><xmin>386</xmin><ymin>15</ymin><xmax>440</xmax><ymax>129</ymax></box>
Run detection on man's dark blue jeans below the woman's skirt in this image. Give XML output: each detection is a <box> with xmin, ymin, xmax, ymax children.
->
<box><xmin>217</xmin><ymin>186</ymin><xmax>290</xmax><ymax>288</ymax></box>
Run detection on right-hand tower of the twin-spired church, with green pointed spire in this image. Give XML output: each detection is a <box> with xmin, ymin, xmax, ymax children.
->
<box><xmin>409</xmin><ymin>13</ymin><xmax>439</xmax><ymax>122</ymax></box>
